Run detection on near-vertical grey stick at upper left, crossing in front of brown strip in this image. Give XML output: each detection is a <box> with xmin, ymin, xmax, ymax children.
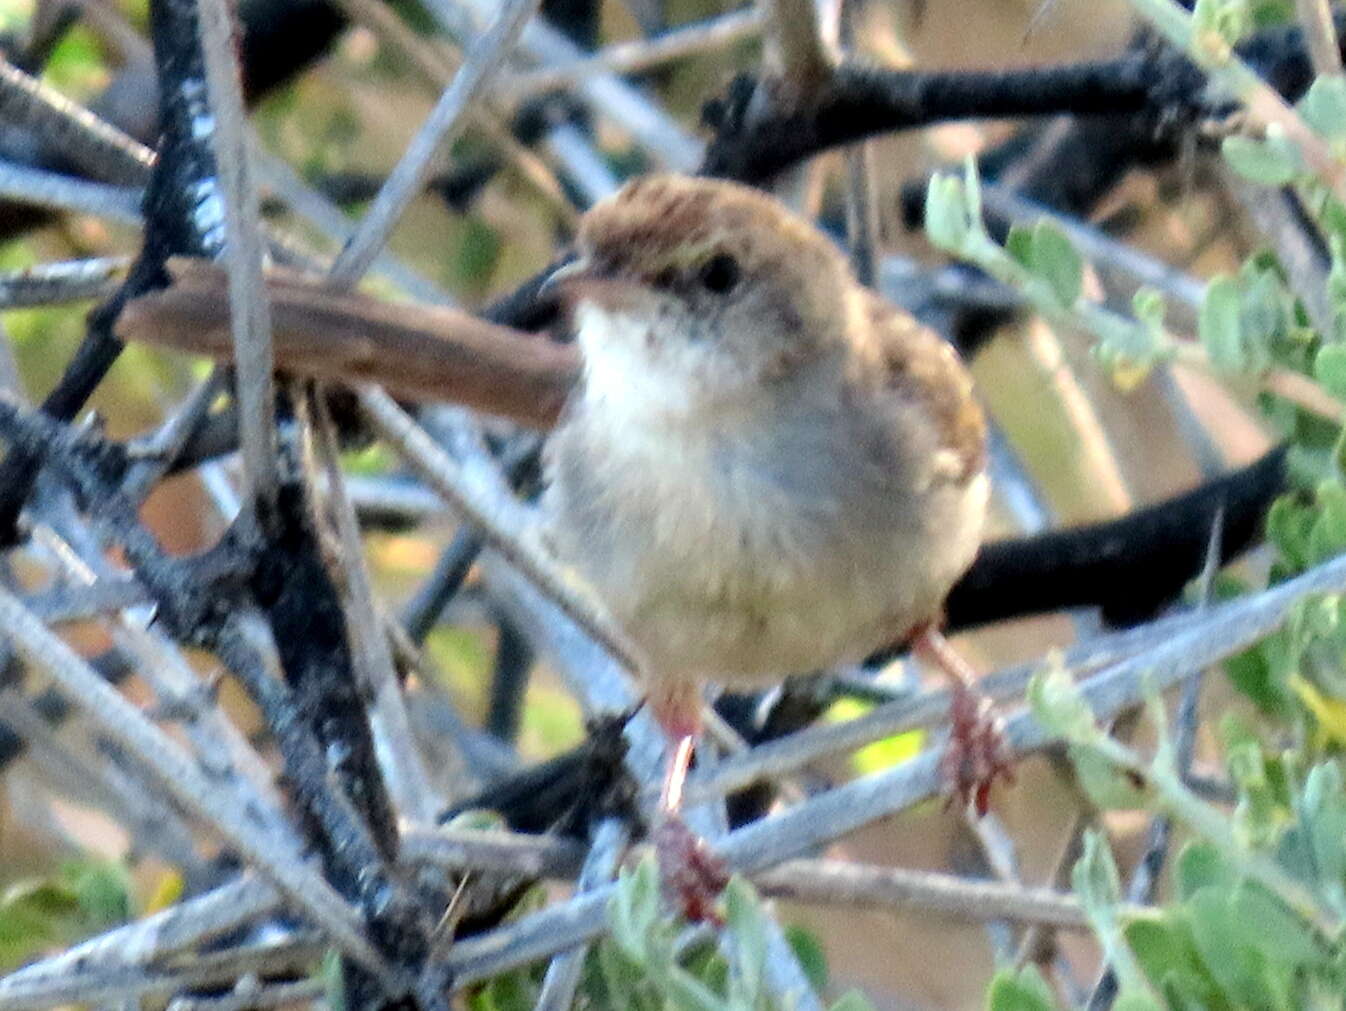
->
<box><xmin>197</xmin><ymin>0</ymin><xmax>280</xmax><ymax>512</ymax></box>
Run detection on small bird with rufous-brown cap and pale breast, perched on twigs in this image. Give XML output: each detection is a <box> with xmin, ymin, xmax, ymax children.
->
<box><xmin>545</xmin><ymin>175</ymin><xmax>1003</xmax><ymax>905</ymax></box>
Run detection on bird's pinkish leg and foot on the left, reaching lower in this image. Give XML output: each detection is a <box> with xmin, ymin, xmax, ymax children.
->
<box><xmin>650</xmin><ymin>684</ymin><xmax>728</xmax><ymax>921</ymax></box>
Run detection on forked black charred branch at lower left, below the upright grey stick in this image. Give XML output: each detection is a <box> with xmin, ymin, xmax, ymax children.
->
<box><xmin>0</xmin><ymin>400</ymin><xmax>432</xmax><ymax>1007</ymax></box>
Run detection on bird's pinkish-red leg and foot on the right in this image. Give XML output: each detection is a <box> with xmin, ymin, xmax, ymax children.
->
<box><xmin>911</xmin><ymin>625</ymin><xmax>1014</xmax><ymax>816</ymax></box>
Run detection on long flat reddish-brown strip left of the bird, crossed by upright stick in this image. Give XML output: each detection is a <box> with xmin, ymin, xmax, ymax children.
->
<box><xmin>117</xmin><ymin>258</ymin><xmax>579</xmax><ymax>428</ymax></box>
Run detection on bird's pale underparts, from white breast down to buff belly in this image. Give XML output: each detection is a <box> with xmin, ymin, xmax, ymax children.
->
<box><xmin>546</xmin><ymin>352</ymin><xmax>987</xmax><ymax>687</ymax></box>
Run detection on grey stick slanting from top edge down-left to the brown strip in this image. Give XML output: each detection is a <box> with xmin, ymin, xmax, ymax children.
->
<box><xmin>331</xmin><ymin>0</ymin><xmax>541</xmax><ymax>284</ymax></box>
